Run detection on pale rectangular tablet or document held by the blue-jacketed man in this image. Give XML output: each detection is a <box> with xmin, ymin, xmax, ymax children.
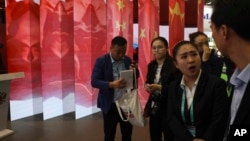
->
<box><xmin>120</xmin><ymin>70</ymin><xmax>134</xmax><ymax>89</ymax></box>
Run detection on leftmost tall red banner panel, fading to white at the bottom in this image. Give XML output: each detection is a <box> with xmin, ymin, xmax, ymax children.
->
<box><xmin>6</xmin><ymin>0</ymin><xmax>42</xmax><ymax>120</ymax></box>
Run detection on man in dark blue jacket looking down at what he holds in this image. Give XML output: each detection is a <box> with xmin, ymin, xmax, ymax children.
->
<box><xmin>91</xmin><ymin>36</ymin><xmax>134</xmax><ymax>141</ymax></box>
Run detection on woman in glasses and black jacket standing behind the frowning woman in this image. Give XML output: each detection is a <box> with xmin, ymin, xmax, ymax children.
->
<box><xmin>145</xmin><ymin>37</ymin><xmax>179</xmax><ymax>141</ymax></box>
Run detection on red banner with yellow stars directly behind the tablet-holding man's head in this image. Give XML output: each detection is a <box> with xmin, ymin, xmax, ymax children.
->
<box><xmin>107</xmin><ymin>0</ymin><xmax>133</xmax><ymax>58</ymax></box>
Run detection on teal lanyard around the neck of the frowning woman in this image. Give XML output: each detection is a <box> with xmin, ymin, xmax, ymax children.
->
<box><xmin>181</xmin><ymin>88</ymin><xmax>194</xmax><ymax>124</ymax></box>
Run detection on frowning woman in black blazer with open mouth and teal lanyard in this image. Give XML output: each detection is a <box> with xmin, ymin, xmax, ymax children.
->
<box><xmin>166</xmin><ymin>41</ymin><xmax>229</xmax><ymax>141</ymax></box>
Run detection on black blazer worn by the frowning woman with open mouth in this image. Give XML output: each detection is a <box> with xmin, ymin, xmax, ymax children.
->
<box><xmin>166</xmin><ymin>72</ymin><xmax>229</xmax><ymax>141</ymax></box>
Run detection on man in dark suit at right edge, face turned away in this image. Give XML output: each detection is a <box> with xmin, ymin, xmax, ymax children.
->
<box><xmin>211</xmin><ymin>0</ymin><xmax>250</xmax><ymax>141</ymax></box>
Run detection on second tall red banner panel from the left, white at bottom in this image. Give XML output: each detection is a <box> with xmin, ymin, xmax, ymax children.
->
<box><xmin>40</xmin><ymin>0</ymin><xmax>75</xmax><ymax>119</ymax></box>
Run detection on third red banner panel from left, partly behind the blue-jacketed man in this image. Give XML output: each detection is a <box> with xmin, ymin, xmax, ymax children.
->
<box><xmin>74</xmin><ymin>0</ymin><xmax>107</xmax><ymax>119</ymax></box>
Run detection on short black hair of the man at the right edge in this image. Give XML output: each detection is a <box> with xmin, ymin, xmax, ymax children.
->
<box><xmin>211</xmin><ymin>0</ymin><xmax>250</xmax><ymax>41</ymax></box>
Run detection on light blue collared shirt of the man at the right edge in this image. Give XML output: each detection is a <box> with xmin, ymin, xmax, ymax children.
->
<box><xmin>230</xmin><ymin>63</ymin><xmax>250</xmax><ymax>124</ymax></box>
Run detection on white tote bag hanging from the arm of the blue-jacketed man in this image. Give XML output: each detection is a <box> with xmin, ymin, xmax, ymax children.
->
<box><xmin>115</xmin><ymin>71</ymin><xmax>146</xmax><ymax>127</ymax></box>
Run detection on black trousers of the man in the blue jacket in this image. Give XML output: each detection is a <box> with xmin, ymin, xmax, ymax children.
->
<box><xmin>103</xmin><ymin>103</ymin><xmax>133</xmax><ymax>141</ymax></box>
